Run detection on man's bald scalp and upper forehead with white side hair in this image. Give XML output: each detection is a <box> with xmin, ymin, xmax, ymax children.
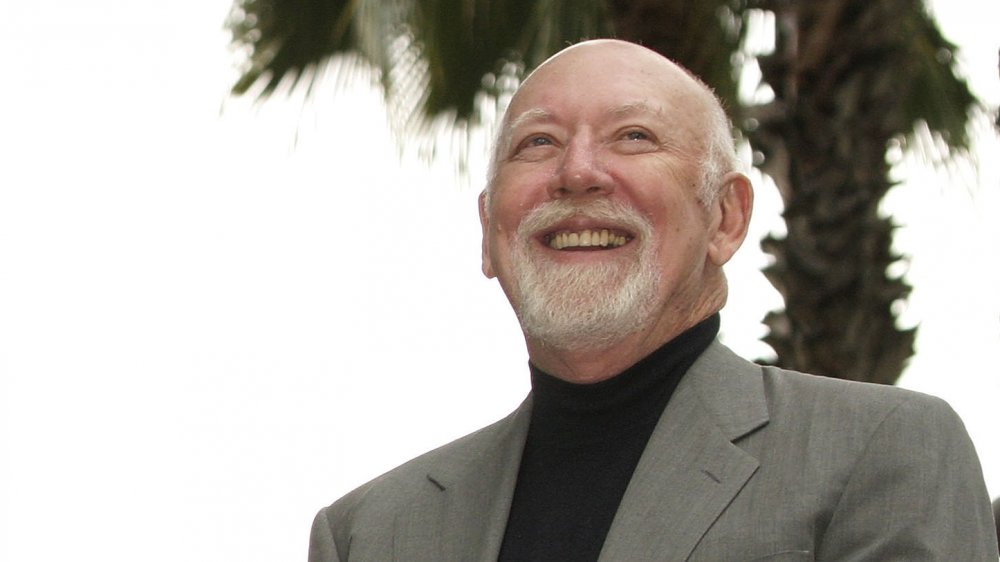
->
<box><xmin>487</xmin><ymin>39</ymin><xmax>740</xmax><ymax>205</ymax></box>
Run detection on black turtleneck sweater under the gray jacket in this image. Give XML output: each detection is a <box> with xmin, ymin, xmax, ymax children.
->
<box><xmin>499</xmin><ymin>314</ymin><xmax>719</xmax><ymax>562</ymax></box>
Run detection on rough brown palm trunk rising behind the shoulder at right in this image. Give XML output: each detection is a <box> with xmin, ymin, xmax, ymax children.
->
<box><xmin>750</xmin><ymin>0</ymin><xmax>922</xmax><ymax>384</ymax></box>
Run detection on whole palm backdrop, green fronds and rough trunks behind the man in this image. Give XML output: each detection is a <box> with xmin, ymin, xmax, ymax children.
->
<box><xmin>229</xmin><ymin>0</ymin><xmax>975</xmax><ymax>383</ymax></box>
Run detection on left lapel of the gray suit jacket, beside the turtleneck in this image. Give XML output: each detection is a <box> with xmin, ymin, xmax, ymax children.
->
<box><xmin>393</xmin><ymin>398</ymin><xmax>531</xmax><ymax>562</ymax></box>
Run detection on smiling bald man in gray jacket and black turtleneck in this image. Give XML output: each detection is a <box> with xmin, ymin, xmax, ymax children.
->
<box><xmin>309</xmin><ymin>40</ymin><xmax>997</xmax><ymax>562</ymax></box>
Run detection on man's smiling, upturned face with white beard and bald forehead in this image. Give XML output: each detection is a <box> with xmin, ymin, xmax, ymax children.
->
<box><xmin>481</xmin><ymin>41</ymin><xmax>749</xmax><ymax>364</ymax></box>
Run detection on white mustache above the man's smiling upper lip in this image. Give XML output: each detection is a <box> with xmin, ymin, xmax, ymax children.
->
<box><xmin>517</xmin><ymin>199</ymin><xmax>653</xmax><ymax>241</ymax></box>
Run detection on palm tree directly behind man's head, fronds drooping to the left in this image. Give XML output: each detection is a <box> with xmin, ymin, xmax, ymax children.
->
<box><xmin>228</xmin><ymin>0</ymin><xmax>740</xmax><ymax>123</ymax></box>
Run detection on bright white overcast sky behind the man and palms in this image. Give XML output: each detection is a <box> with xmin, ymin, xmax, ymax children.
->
<box><xmin>0</xmin><ymin>0</ymin><xmax>1000</xmax><ymax>562</ymax></box>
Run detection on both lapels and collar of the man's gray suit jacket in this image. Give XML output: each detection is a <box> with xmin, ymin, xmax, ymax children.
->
<box><xmin>395</xmin><ymin>342</ymin><xmax>768</xmax><ymax>562</ymax></box>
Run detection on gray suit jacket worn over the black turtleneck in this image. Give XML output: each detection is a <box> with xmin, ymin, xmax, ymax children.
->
<box><xmin>309</xmin><ymin>343</ymin><xmax>998</xmax><ymax>562</ymax></box>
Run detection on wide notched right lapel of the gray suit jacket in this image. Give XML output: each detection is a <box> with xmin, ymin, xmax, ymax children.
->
<box><xmin>600</xmin><ymin>343</ymin><xmax>767</xmax><ymax>562</ymax></box>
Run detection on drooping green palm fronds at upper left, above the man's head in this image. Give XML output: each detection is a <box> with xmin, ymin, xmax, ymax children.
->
<box><xmin>227</xmin><ymin>0</ymin><xmax>611</xmax><ymax>122</ymax></box>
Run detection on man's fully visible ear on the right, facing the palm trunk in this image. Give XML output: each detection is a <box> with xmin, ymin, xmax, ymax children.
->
<box><xmin>708</xmin><ymin>172</ymin><xmax>753</xmax><ymax>267</ymax></box>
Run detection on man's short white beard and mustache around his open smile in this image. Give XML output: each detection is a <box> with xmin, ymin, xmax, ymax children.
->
<box><xmin>511</xmin><ymin>199</ymin><xmax>660</xmax><ymax>350</ymax></box>
